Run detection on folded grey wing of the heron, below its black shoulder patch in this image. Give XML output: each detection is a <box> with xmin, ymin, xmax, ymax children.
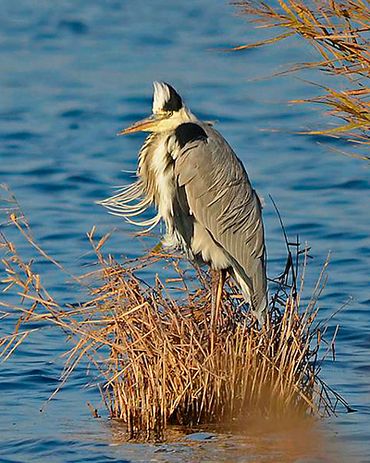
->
<box><xmin>175</xmin><ymin>129</ymin><xmax>267</xmax><ymax>314</ymax></box>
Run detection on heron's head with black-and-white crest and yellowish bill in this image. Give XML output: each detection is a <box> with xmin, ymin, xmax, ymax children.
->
<box><xmin>118</xmin><ymin>82</ymin><xmax>194</xmax><ymax>135</ymax></box>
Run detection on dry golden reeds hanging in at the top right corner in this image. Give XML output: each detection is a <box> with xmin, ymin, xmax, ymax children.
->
<box><xmin>234</xmin><ymin>0</ymin><xmax>370</xmax><ymax>156</ymax></box>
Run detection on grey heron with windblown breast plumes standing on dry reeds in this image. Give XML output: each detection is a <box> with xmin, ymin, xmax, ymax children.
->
<box><xmin>101</xmin><ymin>82</ymin><xmax>267</xmax><ymax>322</ymax></box>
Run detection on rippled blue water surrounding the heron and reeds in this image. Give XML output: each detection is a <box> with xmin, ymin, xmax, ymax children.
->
<box><xmin>0</xmin><ymin>0</ymin><xmax>370</xmax><ymax>462</ymax></box>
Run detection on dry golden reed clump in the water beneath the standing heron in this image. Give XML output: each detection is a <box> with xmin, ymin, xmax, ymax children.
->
<box><xmin>0</xmin><ymin>205</ymin><xmax>345</xmax><ymax>440</ymax></box>
